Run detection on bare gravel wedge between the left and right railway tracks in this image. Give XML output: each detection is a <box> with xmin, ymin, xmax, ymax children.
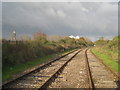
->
<box><xmin>48</xmin><ymin>50</ymin><xmax>89</xmax><ymax>88</ymax></box>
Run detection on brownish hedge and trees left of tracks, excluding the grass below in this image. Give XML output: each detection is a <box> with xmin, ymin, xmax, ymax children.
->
<box><xmin>2</xmin><ymin>32</ymin><xmax>93</xmax><ymax>68</ymax></box>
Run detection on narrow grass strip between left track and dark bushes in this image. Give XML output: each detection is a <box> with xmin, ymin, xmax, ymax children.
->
<box><xmin>2</xmin><ymin>49</ymin><xmax>76</xmax><ymax>81</ymax></box>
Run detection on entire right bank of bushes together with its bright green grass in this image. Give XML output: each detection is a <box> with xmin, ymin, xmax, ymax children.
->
<box><xmin>92</xmin><ymin>35</ymin><xmax>120</xmax><ymax>73</ymax></box>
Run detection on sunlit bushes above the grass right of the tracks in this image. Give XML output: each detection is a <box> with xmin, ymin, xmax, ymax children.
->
<box><xmin>95</xmin><ymin>36</ymin><xmax>120</xmax><ymax>61</ymax></box>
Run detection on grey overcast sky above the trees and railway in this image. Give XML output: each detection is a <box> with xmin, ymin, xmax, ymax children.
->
<box><xmin>2</xmin><ymin>2</ymin><xmax>118</xmax><ymax>40</ymax></box>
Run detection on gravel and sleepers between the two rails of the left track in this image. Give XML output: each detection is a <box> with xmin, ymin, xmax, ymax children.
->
<box><xmin>3</xmin><ymin>50</ymin><xmax>79</xmax><ymax>88</ymax></box>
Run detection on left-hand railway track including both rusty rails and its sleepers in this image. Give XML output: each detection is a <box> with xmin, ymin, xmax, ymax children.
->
<box><xmin>2</xmin><ymin>49</ymin><xmax>81</xmax><ymax>89</ymax></box>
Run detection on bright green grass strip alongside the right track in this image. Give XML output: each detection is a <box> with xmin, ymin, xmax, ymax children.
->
<box><xmin>92</xmin><ymin>49</ymin><xmax>120</xmax><ymax>72</ymax></box>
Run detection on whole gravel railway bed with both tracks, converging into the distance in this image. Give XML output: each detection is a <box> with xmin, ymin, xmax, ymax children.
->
<box><xmin>3</xmin><ymin>49</ymin><xmax>119</xmax><ymax>90</ymax></box>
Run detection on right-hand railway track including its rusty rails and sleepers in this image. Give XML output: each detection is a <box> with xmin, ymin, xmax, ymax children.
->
<box><xmin>85</xmin><ymin>49</ymin><xmax>119</xmax><ymax>89</ymax></box>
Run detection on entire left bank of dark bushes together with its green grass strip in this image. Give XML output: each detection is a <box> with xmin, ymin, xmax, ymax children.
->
<box><xmin>2</xmin><ymin>34</ymin><xmax>93</xmax><ymax>81</ymax></box>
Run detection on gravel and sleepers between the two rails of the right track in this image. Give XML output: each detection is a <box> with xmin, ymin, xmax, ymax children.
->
<box><xmin>87</xmin><ymin>50</ymin><xmax>118</xmax><ymax>88</ymax></box>
